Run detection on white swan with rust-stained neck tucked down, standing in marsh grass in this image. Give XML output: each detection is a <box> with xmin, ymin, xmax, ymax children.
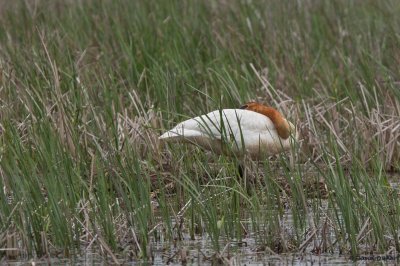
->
<box><xmin>159</xmin><ymin>105</ymin><xmax>294</xmax><ymax>159</ymax></box>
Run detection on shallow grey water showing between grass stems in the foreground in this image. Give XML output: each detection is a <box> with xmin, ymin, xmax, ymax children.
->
<box><xmin>0</xmin><ymin>176</ymin><xmax>400</xmax><ymax>265</ymax></box>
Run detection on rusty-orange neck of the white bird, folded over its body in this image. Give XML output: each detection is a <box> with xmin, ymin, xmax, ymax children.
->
<box><xmin>240</xmin><ymin>102</ymin><xmax>291</xmax><ymax>139</ymax></box>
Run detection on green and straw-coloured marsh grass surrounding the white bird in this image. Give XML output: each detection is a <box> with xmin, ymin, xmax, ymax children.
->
<box><xmin>0</xmin><ymin>0</ymin><xmax>400</xmax><ymax>263</ymax></box>
